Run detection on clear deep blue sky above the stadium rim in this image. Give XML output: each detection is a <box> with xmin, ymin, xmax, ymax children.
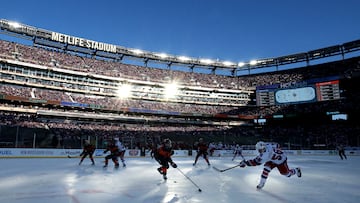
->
<box><xmin>0</xmin><ymin>0</ymin><xmax>360</xmax><ymax>65</ymax></box>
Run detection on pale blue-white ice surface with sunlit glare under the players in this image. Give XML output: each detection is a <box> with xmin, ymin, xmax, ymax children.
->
<box><xmin>0</xmin><ymin>155</ymin><xmax>360</xmax><ymax>203</ymax></box>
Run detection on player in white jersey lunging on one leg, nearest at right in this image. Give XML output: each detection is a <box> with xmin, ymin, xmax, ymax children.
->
<box><xmin>239</xmin><ymin>141</ymin><xmax>301</xmax><ymax>189</ymax></box>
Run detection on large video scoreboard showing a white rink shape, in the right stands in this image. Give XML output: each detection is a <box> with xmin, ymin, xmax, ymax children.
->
<box><xmin>256</xmin><ymin>80</ymin><xmax>340</xmax><ymax>106</ymax></box>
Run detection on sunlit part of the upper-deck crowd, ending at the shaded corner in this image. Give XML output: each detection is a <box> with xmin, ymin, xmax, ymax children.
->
<box><xmin>0</xmin><ymin>40</ymin><xmax>247</xmax><ymax>89</ymax></box>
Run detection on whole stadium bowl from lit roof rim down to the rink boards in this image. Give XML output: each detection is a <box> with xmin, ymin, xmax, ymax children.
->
<box><xmin>0</xmin><ymin>19</ymin><xmax>360</xmax><ymax>148</ymax></box>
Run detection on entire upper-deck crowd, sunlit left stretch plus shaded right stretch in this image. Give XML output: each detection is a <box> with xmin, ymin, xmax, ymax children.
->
<box><xmin>0</xmin><ymin>40</ymin><xmax>356</xmax><ymax>89</ymax></box>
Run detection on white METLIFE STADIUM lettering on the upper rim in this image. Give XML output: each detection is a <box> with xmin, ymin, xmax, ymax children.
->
<box><xmin>51</xmin><ymin>32</ymin><xmax>116</xmax><ymax>53</ymax></box>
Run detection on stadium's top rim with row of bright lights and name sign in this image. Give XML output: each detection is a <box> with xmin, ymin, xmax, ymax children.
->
<box><xmin>0</xmin><ymin>19</ymin><xmax>360</xmax><ymax>76</ymax></box>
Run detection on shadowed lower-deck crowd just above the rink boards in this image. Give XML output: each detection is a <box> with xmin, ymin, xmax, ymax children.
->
<box><xmin>0</xmin><ymin>108</ymin><xmax>360</xmax><ymax>149</ymax></box>
